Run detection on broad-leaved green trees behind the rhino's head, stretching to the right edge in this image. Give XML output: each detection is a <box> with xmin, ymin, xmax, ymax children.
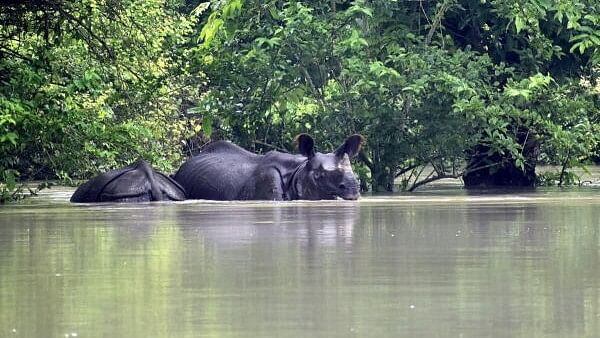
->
<box><xmin>186</xmin><ymin>0</ymin><xmax>598</xmax><ymax>190</ymax></box>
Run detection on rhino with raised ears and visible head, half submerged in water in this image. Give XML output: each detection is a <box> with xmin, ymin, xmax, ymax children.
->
<box><xmin>174</xmin><ymin>134</ymin><xmax>363</xmax><ymax>201</ymax></box>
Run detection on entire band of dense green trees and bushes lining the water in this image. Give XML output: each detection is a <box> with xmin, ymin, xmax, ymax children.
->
<box><xmin>0</xmin><ymin>0</ymin><xmax>600</xmax><ymax>200</ymax></box>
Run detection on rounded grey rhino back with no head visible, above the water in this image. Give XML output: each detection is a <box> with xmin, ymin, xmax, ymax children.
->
<box><xmin>71</xmin><ymin>160</ymin><xmax>185</xmax><ymax>203</ymax></box>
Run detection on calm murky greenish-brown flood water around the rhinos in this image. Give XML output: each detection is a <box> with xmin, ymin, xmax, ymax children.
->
<box><xmin>0</xmin><ymin>188</ymin><xmax>600</xmax><ymax>337</ymax></box>
